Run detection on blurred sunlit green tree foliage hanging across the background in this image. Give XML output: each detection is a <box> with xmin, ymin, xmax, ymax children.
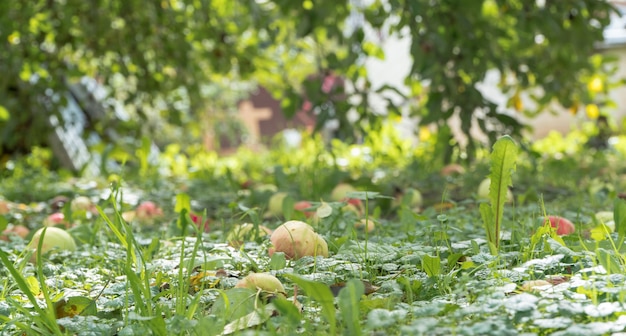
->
<box><xmin>0</xmin><ymin>0</ymin><xmax>614</xmax><ymax>163</ymax></box>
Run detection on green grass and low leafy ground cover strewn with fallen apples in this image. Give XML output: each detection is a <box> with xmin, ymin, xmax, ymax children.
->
<box><xmin>0</xmin><ymin>127</ymin><xmax>626</xmax><ymax>335</ymax></box>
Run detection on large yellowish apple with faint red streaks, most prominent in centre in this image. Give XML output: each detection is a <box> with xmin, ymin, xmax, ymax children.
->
<box><xmin>268</xmin><ymin>220</ymin><xmax>328</xmax><ymax>260</ymax></box>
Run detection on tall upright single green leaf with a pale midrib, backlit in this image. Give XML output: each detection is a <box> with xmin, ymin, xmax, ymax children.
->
<box><xmin>480</xmin><ymin>135</ymin><xmax>517</xmax><ymax>255</ymax></box>
